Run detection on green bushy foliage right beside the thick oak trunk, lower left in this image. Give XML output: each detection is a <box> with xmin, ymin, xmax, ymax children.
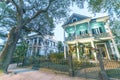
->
<box><xmin>13</xmin><ymin>41</ymin><xmax>28</xmax><ymax>63</ymax></box>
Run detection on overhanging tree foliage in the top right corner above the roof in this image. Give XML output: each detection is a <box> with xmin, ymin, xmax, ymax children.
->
<box><xmin>88</xmin><ymin>0</ymin><xmax>120</xmax><ymax>18</ymax></box>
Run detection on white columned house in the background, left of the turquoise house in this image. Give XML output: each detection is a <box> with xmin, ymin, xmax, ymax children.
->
<box><xmin>27</xmin><ymin>34</ymin><xmax>58</xmax><ymax>56</ymax></box>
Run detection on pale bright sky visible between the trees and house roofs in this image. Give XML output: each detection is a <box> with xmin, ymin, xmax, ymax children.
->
<box><xmin>54</xmin><ymin>4</ymin><xmax>107</xmax><ymax>41</ymax></box>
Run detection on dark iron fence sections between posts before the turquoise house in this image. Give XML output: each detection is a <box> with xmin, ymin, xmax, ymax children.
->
<box><xmin>32</xmin><ymin>59</ymin><xmax>120</xmax><ymax>80</ymax></box>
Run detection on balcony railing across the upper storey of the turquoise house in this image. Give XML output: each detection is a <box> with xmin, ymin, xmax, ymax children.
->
<box><xmin>65</xmin><ymin>33</ymin><xmax>110</xmax><ymax>41</ymax></box>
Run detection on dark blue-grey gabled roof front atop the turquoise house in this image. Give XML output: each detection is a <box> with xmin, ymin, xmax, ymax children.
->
<box><xmin>63</xmin><ymin>13</ymin><xmax>90</xmax><ymax>25</ymax></box>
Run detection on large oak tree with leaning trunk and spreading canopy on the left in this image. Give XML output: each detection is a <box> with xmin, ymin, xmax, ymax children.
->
<box><xmin>0</xmin><ymin>0</ymin><xmax>83</xmax><ymax>72</ymax></box>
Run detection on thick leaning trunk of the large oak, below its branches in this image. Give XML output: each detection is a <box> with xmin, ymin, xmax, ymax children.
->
<box><xmin>0</xmin><ymin>27</ymin><xmax>21</xmax><ymax>73</ymax></box>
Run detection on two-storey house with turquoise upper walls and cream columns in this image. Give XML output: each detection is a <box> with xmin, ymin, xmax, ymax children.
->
<box><xmin>62</xmin><ymin>14</ymin><xmax>120</xmax><ymax>60</ymax></box>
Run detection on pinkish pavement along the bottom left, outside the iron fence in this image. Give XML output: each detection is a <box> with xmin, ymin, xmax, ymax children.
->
<box><xmin>0</xmin><ymin>69</ymin><xmax>86</xmax><ymax>80</ymax></box>
